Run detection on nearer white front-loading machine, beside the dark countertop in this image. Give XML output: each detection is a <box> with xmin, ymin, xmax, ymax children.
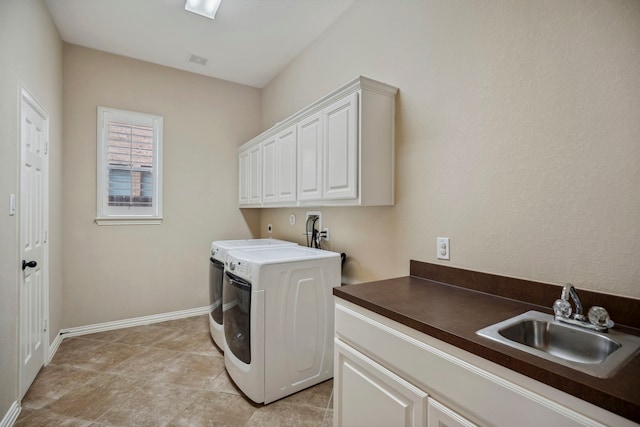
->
<box><xmin>222</xmin><ymin>246</ymin><xmax>341</xmax><ymax>404</ymax></box>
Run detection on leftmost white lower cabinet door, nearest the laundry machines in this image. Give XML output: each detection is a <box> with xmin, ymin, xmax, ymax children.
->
<box><xmin>333</xmin><ymin>339</ymin><xmax>427</xmax><ymax>427</ymax></box>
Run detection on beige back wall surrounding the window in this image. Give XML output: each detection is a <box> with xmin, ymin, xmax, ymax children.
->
<box><xmin>63</xmin><ymin>45</ymin><xmax>260</xmax><ymax>327</ymax></box>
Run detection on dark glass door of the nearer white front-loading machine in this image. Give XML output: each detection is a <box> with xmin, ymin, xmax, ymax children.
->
<box><xmin>222</xmin><ymin>272</ymin><xmax>251</xmax><ymax>365</ymax></box>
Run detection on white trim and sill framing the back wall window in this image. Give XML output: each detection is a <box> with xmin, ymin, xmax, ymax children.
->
<box><xmin>95</xmin><ymin>106</ymin><xmax>164</xmax><ymax>225</ymax></box>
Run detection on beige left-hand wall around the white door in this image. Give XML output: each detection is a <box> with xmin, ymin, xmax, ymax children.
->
<box><xmin>0</xmin><ymin>0</ymin><xmax>62</xmax><ymax>419</ymax></box>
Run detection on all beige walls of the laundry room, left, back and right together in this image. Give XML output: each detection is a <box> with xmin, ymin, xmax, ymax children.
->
<box><xmin>0</xmin><ymin>0</ymin><xmax>640</xmax><ymax>415</ymax></box>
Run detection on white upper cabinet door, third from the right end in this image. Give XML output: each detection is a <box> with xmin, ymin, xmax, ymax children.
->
<box><xmin>274</xmin><ymin>126</ymin><xmax>297</xmax><ymax>202</ymax></box>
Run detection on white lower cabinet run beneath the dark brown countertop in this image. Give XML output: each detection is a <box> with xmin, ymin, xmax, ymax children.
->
<box><xmin>333</xmin><ymin>298</ymin><xmax>637</xmax><ymax>427</ymax></box>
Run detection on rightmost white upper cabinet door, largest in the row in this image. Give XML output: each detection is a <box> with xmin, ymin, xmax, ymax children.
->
<box><xmin>323</xmin><ymin>93</ymin><xmax>358</xmax><ymax>199</ymax></box>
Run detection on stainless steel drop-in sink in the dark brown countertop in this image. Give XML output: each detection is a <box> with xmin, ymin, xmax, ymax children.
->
<box><xmin>477</xmin><ymin>311</ymin><xmax>640</xmax><ymax>378</ymax></box>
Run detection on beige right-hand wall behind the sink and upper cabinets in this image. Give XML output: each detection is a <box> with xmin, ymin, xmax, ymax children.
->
<box><xmin>260</xmin><ymin>0</ymin><xmax>640</xmax><ymax>304</ymax></box>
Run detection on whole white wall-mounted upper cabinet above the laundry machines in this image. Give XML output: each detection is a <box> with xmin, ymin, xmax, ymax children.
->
<box><xmin>238</xmin><ymin>76</ymin><xmax>398</xmax><ymax>207</ymax></box>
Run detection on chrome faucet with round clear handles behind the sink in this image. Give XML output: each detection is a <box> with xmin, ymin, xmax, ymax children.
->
<box><xmin>553</xmin><ymin>283</ymin><xmax>614</xmax><ymax>332</ymax></box>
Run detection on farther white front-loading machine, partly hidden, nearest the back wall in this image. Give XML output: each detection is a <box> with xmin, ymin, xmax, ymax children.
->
<box><xmin>209</xmin><ymin>239</ymin><xmax>298</xmax><ymax>351</ymax></box>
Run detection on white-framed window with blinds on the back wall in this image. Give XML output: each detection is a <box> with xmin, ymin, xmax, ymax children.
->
<box><xmin>96</xmin><ymin>107</ymin><xmax>162</xmax><ymax>224</ymax></box>
